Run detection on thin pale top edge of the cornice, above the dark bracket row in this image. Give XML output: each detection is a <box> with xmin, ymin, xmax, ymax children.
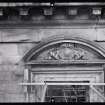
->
<box><xmin>0</xmin><ymin>2</ymin><xmax>105</xmax><ymax>7</ymax></box>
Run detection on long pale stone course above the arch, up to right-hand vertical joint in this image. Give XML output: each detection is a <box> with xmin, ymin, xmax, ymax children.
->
<box><xmin>1</xmin><ymin>28</ymin><xmax>96</xmax><ymax>42</ymax></box>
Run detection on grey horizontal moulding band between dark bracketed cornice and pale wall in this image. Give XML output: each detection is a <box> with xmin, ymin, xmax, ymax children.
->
<box><xmin>0</xmin><ymin>20</ymin><xmax>105</xmax><ymax>29</ymax></box>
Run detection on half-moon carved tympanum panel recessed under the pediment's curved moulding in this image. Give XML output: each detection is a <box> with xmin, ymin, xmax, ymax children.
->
<box><xmin>32</xmin><ymin>42</ymin><xmax>102</xmax><ymax>60</ymax></box>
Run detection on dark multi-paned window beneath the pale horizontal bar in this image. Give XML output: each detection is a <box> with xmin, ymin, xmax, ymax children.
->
<box><xmin>45</xmin><ymin>81</ymin><xmax>89</xmax><ymax>102</ymax></box>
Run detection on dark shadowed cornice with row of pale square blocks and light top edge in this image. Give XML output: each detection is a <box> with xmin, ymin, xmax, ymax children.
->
<box><xmin>0</xmin><ymin>2</ymin><xmax>105</xmax><ymax>21</ymax></box>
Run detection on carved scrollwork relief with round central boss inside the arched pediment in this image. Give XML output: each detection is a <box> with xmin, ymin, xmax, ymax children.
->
<box><xmin>47</xmin><ymin>43</ymin><xmax>87</xmax><ymax>60</ymax></box>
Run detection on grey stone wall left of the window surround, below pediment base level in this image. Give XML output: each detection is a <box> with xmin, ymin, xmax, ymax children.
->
<box><xmin>0</xmin><ymin>62</ymin><xmax>23</xmax><ymax>102</ymax></box>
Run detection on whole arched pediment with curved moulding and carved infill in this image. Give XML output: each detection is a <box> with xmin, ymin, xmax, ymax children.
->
<box><xmin>23</xmin><ymin>36</ymin><xmax>105</xmax><ymax>62</ymax></box>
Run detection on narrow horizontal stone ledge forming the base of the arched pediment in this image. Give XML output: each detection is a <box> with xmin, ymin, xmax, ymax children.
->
<box><xmin>25</xmin><ymin>60</ymin><xmax>105</xmax><ymax>65</ymax></box>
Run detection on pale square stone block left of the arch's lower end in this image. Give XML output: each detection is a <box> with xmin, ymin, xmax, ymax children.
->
<box><xmin>0</xmin><ymin>44</ymin><xmax>20</xmax><ymax>63</ymax></box>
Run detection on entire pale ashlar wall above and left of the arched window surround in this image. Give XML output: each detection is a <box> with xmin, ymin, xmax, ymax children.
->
<box><xmin>0</xmin><ymin>25</ymin><xmax>105</xmax><ymax>102</ymax></box>
